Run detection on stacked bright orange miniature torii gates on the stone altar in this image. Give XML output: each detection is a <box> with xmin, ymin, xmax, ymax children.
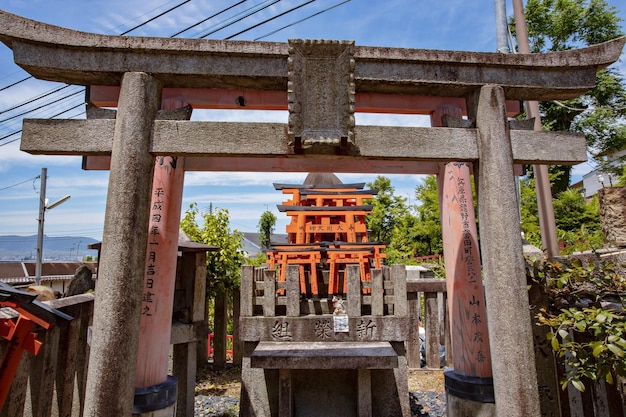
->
<box><xmin>267</xmin><ymin>174</ymin><xmax>386</xmax><ymax>298</ymax></box>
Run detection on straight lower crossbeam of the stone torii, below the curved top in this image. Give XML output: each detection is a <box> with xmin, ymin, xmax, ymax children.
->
<box><xmin>21</xmin><ymin>119</ymin><xmax>587</xmax><ymax>174</ymax></box>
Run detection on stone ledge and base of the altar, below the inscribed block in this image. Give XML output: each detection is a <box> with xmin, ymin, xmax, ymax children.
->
<box><xmin>240</xmin><ymin>342</ymin><xmax>410</xmax><ymax>417</ymax></box>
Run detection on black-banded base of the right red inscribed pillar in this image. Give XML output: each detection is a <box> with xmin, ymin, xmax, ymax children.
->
<box><xmin>444</xmin><ymin>370</ymin><xmax>496</xmax><ymax>417</ymax></box>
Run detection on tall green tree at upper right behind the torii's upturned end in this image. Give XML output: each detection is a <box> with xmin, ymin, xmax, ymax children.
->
<box><xmin>525</xmin><ymin>0</ymin><xmax>626</xmax><ymax>195</ymax></box>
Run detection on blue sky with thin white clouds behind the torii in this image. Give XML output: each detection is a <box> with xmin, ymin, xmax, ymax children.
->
<box><xmin>0</xmin><ymin>0</ymin><xmax>626</xmax><ymax>239</ymax></box>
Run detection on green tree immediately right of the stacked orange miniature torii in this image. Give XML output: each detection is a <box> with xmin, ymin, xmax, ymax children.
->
<box><xmin>366</xmin><ymin>176</ymin><xmax>408</xmax><ymax>242</ymax></box>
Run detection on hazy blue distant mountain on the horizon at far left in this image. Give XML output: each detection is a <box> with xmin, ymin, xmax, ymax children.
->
<box><xmin>0</xmin><ymin>235</ymin><xmax>98</xmax><ymax>261</ymax></box>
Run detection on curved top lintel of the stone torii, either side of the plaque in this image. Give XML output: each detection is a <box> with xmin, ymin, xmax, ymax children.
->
<box><xmin>0</xmin><ymin>12</ymin><xmax>625</xmax><ymax>100</ymax></box>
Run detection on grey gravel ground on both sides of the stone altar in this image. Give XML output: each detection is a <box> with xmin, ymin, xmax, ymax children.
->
<box><xmin>195</xmin><ymin>391</ymin><xmax>446</xmax><ymax>417</ymax></box>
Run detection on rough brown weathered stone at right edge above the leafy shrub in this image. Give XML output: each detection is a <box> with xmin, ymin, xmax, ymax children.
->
<box><xmin>598</xmin><ymin>187</ymin><xmax>626</xmax><ymax>246</ymax></box>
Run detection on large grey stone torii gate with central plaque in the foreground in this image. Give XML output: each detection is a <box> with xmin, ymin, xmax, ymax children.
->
<box><xmin>0</xmin><ymin>12</ymin><xmax>624</xmax><ymax>417</ymax></box>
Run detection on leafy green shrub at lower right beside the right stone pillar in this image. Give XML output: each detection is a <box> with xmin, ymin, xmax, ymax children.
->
<box><xmin>534</xmin><ymin>256</ymin><xmax>626</xmax><ymax>391</ymax></box>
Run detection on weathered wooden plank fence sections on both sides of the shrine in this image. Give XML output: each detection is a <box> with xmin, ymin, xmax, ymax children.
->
<box><xmin>0</xmin><ymin>260</ymin><xmax>624</xmax><ymax>417</ymax></box>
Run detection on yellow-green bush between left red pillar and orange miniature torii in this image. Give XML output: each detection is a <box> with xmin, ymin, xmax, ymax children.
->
<box><xmin>180</xmin><ymin>203</ymin><xmax>244</xmax><ymax>297</ymax></box>
